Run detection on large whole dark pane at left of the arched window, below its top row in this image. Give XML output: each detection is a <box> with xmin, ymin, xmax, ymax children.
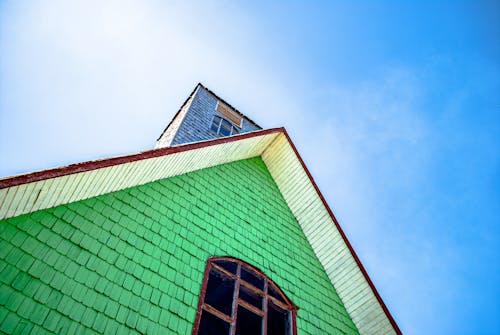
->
<box><xmin>205</xmin><ymin>269</ymin><xmax>235</xmax><ymax>316</ymax></box>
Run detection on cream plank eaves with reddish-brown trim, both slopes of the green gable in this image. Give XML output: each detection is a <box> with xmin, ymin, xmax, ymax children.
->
<box><xmin>0</xmin><ymin>128</ymin><xmax>401</xmax><ymax>335</ymax></box>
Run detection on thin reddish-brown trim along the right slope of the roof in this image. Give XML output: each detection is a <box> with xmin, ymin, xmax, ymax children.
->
<box><xmin>283</xmin><ymin>128</ymin><xmax>403</xmax><ymax>335</ymax></box>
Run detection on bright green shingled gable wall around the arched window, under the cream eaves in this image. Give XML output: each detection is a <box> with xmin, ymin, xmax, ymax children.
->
<box><xmin>0</xmin><ymin>158</ymin><xmax>358</xmax><ymax>335</ymax></box>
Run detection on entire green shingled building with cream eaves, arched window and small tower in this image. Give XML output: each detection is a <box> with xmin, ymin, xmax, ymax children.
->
<box><xmin>0</xmin><ymin>84</ymin><xmax>401</xmax><ymax>335</ymax></box>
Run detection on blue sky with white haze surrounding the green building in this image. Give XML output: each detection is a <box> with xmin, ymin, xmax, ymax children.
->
<box><xmin>0</xmin><ymin>0</ymin><xmax>500</xmax><ymax>335</ymax></box>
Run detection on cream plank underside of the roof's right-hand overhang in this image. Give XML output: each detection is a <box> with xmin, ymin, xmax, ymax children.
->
<box><xmin>262</xmin><ymin>135</ymin><xmax>396</xmax><ymax>335</ymax></box>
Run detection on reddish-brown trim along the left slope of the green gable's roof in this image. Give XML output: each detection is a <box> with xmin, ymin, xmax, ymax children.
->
<box><xmin>0</xmin><ymin>127</ymin><xmax>285</xmax><ymax>189</ymax></box>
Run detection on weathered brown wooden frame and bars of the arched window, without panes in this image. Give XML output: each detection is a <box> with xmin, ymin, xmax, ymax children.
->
<box><xmin>191</xmin><ymin>256</ymin><xmax>299</xmax><ymax>335</ymax></box>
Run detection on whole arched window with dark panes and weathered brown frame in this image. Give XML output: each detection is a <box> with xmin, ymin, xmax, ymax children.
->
<box><xmin>192</xmin><ymin>257</ymin><xmax>298</xmax><ymax>335</ymax></box>
